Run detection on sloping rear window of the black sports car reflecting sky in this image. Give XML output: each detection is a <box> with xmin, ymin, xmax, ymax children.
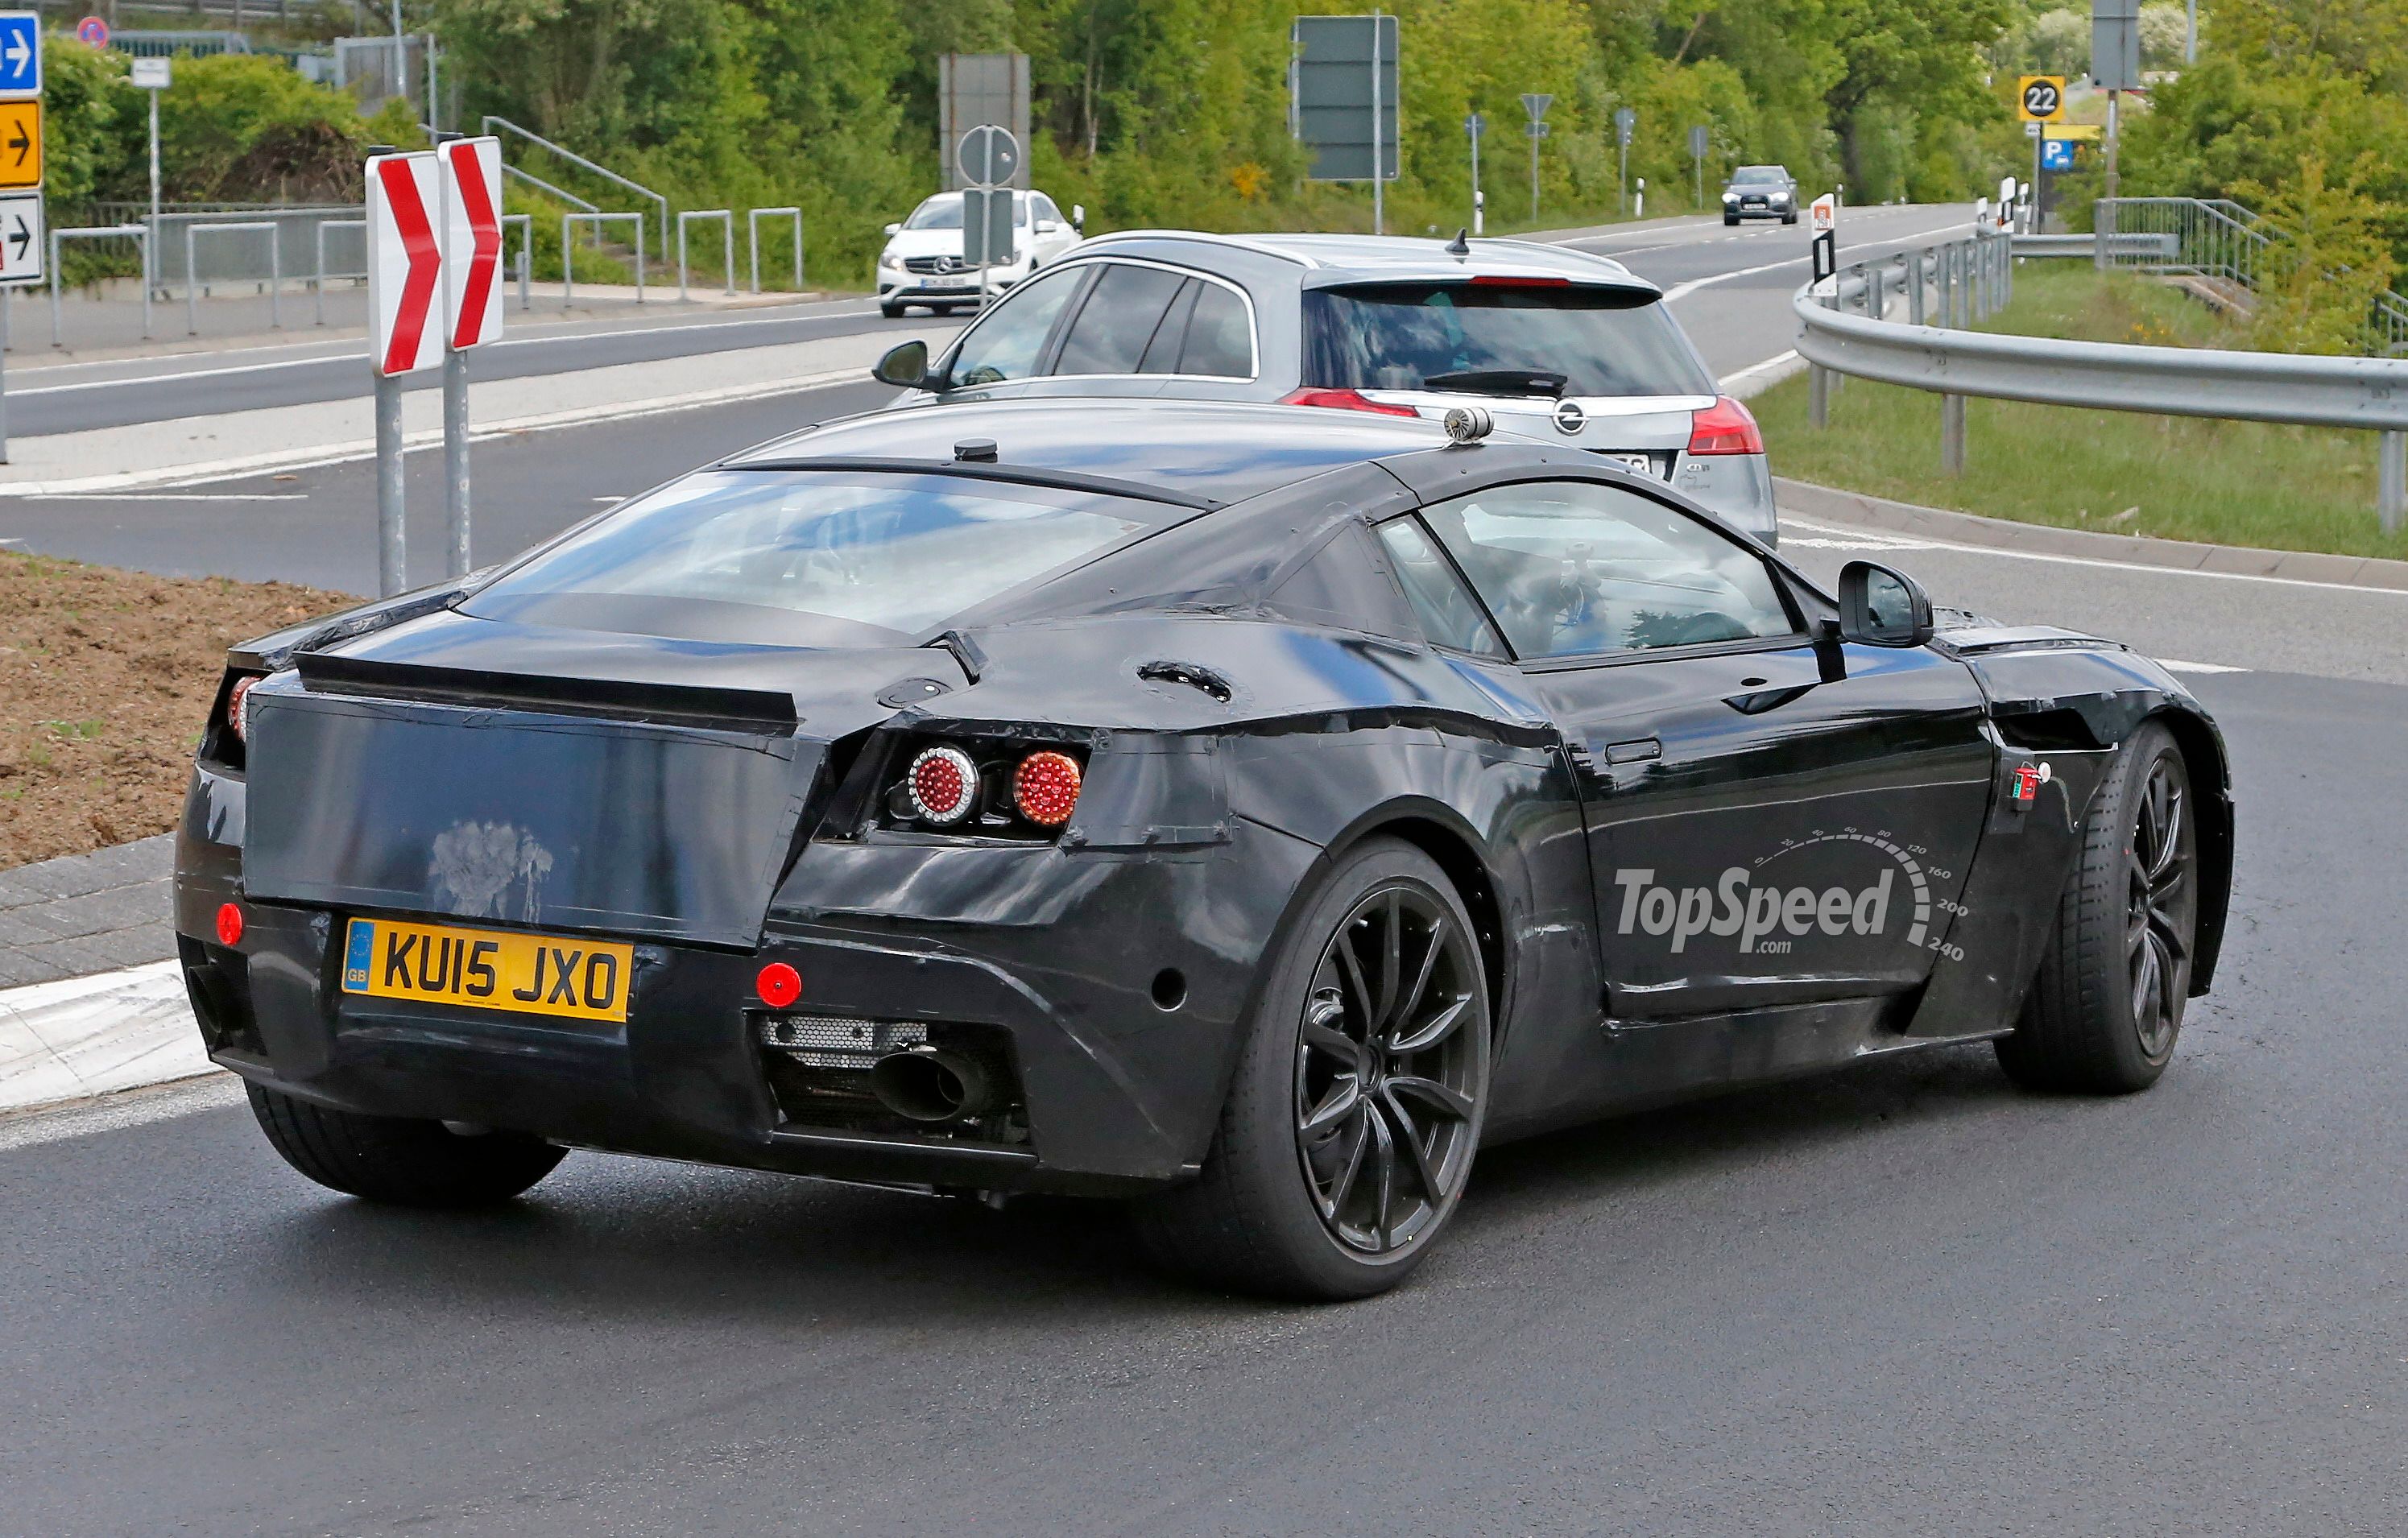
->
<box><xmin>462</xmin><ymin>469</ymin><xmax>1144</xmax><ymax>645</ymax></box>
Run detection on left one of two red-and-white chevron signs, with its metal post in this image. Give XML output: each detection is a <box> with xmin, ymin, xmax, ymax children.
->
<box><xmin>368</xmin><ymin>149</ymin><xmax>445</xmax><ymax>597</ymax></box>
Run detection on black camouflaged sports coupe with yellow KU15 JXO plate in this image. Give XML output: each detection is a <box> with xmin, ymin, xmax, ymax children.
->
<box><xmin>176</xmin><ymin>399</ymin><xmax>2232</xmax><ymax>1297</ymax></box>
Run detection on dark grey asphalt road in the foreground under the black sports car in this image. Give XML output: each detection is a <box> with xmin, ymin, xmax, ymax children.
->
<box><xmin>0</xmin><ymin>655</ymin><xmax>2408</xmax><ymax>1538</ymax></box>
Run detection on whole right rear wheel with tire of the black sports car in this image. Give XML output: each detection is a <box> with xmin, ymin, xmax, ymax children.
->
<box><xmin>1134</xmin><ymin>837</ymin><xmax>1488</xmax><ymax>1300</ymax></box>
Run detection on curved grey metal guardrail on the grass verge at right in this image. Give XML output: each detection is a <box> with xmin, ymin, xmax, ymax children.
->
<box><xmin>1792</xmin><ymin>228</ymin><xmax>2408</xmax><ymax>535</ymax></box>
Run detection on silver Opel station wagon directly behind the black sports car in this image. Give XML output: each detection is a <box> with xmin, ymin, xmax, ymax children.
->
<box><xmin>876</xmin><ymin>231</ymin><xmax>1777</xmax><ymax>544</ymax></box>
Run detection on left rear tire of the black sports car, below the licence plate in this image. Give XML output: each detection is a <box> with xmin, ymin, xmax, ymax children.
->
<box><xmin>246</xmin><ymin>1083</ymin><xmax>569</xmax><ymax>1206</ymax></box>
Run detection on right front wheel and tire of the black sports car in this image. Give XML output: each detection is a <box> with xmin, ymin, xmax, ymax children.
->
<box><xmin>1999</xmin><ymin>722</ymin><xmax>2199</xmax><ymax>1095</ymax></box>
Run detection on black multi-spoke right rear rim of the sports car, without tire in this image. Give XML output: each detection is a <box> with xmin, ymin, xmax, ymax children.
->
<box><xmin>1296</xmin><ymin>881</ymin><xmax>1486</xmax><ymax>1254</ymax></box>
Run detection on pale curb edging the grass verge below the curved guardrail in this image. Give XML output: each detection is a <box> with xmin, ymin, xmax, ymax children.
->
<box><xmin>1773</xmin><ymin>477</ymin><xmax>2408</xmax><ymax>592</ymax></box>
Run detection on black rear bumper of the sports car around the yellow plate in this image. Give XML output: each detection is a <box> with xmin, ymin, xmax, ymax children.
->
<box><xmin>176</xmin><ymin>770</ymin><xmax>1279</xmax><ymax>1194</ymax></box>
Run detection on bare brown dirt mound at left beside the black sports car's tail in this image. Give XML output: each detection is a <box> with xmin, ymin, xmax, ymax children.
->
<box><xmin>0</xmin><ymin>551</ymin><xmax>357</xmax><ymax>869</ymax></box>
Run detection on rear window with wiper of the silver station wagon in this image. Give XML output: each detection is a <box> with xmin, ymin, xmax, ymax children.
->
<box><xmin>1303</xmin><ymin>282</ymin><xmax>1715</xmax><ymax>395</ymax></box>
